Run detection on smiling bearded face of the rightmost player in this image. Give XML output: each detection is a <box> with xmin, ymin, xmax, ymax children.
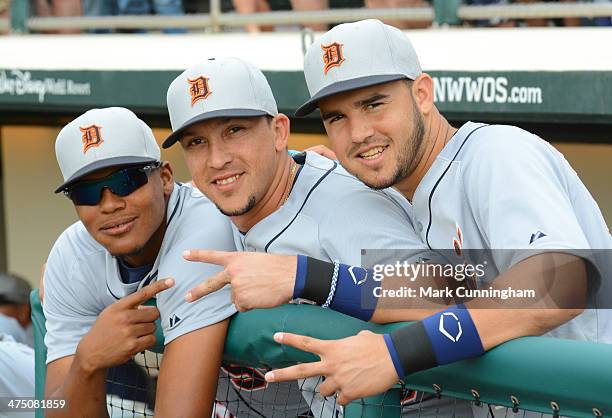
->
<box><xmin>319</xmin><ymin>80</ymin><xmax>425</xmax><ymax>189</ymax></box>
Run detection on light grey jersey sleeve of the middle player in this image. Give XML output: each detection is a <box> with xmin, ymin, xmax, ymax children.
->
<box><xmin>319</xmin><ymin>189</ymin><xmax>438</xmax><ymax>267</ymax></box>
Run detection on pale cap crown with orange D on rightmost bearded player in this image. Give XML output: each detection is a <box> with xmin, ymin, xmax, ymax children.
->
<box><xmin>304</xmin><ymin>20</ymin><xmax>420</xmax><ymax>96</ymax></box>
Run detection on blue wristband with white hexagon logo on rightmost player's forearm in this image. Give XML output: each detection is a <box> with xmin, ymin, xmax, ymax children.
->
<box><xmin>422</xmin><ymin>305</ymin><xmax>485</xmax><ymax>364</ymax></box>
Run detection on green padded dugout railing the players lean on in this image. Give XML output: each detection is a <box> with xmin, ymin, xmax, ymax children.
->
<box><xmin>31</xmin><ymin>291</ymin><xmax>612</xmax><ymax>418</ymax></box>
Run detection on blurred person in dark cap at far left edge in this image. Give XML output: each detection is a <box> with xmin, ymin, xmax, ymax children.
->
<box><xmin>0</xmin><ymin>273</ymin><xmax>34</xmax><ymax>347</ymax></box>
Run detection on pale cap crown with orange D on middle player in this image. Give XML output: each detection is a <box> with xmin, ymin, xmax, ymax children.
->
<box><xmin>168</xmin><ymin>58</ymin><xmax>275</xmax><ymax>130</ymax></box>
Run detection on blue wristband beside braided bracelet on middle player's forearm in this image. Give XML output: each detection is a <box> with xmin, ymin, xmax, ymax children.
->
<box><xmin>329</xmin><ymin>264</ymin><xmax>378</xmax><ymax>321</ymax></box>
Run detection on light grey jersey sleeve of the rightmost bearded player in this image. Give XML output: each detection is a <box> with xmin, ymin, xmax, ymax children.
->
<box><xmin>463</xmin><ymin>127</ymin><xmax>589</xmax><ymax>271</ymax></box>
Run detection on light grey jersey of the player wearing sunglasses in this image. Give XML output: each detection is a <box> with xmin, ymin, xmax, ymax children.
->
<box><xmin>43</xmin><ymin>184</ymin><xmax>236</xmax><ymax>363</ymax></box>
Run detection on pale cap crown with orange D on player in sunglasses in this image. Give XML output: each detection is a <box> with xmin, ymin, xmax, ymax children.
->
<box><xmin>55</xmin><ymin>109</ymin><xmax>159</xmax><ymax>180</ymax></box>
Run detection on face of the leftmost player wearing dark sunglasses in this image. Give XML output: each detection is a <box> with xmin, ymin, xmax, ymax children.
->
<box><xmin>75</xmin><ymin>163</ymin><xmax>173</xmax><ymax>266</ymax></box>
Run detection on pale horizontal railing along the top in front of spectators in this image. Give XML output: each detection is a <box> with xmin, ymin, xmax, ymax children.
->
<box><xmin>0</xmin><ymin>0</ymin><xmax>612</xmax><ymax>33</ymax></box>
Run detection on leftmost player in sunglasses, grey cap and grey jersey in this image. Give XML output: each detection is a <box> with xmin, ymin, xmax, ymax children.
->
<box><xmin>43</xmin><ymin>108</ymin><xmax>235</xmax><ymax>417</ymax></box>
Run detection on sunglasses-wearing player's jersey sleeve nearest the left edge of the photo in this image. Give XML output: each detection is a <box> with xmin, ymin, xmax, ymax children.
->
<box><xmin>43</xmin><ymin>236</ymin><xmax>99</xmax><ymax>364</ymax></box>
